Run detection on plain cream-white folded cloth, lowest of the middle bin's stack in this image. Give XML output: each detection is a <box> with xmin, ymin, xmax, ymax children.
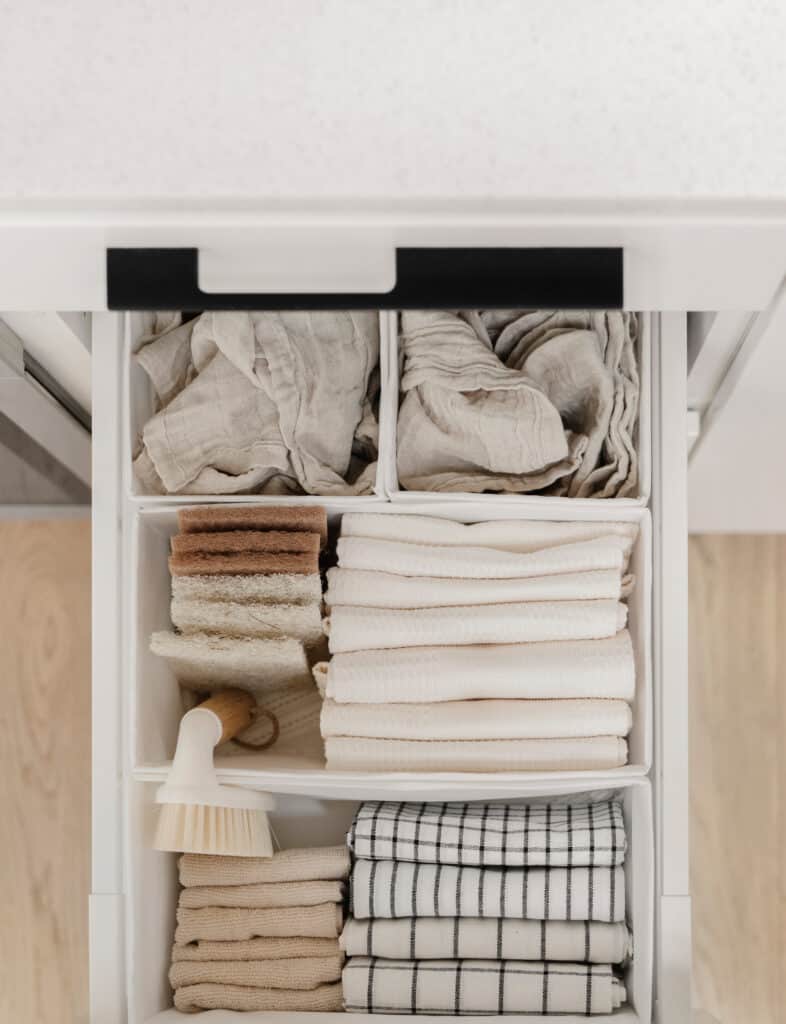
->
<box><xmin>324</xmin><ymin>736</ymin><xmax>627</xmax><ymax>772</ymax></box>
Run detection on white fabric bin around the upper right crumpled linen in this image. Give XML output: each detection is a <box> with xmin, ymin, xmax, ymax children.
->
<box><xmin>385</xmin><ymin>311</ymin><xmax>653</xmax><ymax>509</ymax></box>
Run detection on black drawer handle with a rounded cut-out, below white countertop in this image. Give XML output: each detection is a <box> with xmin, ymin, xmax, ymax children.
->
<box><xmin>106</xmin><ymin>248</ymin><xmax>623</xmax><ymax>310</ymax></box>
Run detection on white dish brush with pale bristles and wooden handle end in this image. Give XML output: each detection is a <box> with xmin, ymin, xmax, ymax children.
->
<box><xmin>152</xmin><ymin>689</ymin><xmax>275</xmax><ymax>857</ymax></box>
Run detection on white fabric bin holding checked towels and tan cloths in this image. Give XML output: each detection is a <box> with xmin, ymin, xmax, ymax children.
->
<box><xmin>127</xmin><ymin>779</ymin><xmax>654</xmax><ymax>1024</ymax></box>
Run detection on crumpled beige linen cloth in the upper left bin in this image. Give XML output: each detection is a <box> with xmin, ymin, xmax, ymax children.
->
<box><xmin>134</xmin><ymin>311</ymin><xmax>380</xmax><ymax>495</ymax></box>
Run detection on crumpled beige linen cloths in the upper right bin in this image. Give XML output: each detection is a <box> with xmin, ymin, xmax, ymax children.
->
<box><xmin>397</xmin><ymin>310</ymin><xmax>639</xmax><ymax>498</ymax></box>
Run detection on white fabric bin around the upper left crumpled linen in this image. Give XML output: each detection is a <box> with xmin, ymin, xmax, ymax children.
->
<box><xmin>123</xmin><ymin>312</ymin><xmax>392</xmax><ymax>506</ymax></box>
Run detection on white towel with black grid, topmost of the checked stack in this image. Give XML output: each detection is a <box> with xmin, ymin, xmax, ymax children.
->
<box><xmin>347</xmin><ymin>800</ymin><xmax>625</xmax><ymax>867</ymax></box>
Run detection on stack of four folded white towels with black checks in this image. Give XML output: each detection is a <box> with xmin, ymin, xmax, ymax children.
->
<box><xmin>341</xmin><ymin>800</ymin><xmax>631</xmax><ymax>1016</ymax></box>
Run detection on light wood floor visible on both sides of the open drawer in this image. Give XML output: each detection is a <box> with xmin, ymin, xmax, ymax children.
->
<box><xmin>0</xmin><ymin>520</ymin><xmax>786</xmax><ymax>1024</ymax></box>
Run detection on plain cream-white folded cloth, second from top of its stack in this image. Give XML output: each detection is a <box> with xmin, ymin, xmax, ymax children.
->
<box><xmin>337</xmin><ymin>536</ymin><xmax>628</xmax><ymax>580</ymax></box>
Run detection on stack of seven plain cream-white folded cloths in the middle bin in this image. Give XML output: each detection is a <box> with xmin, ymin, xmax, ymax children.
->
<box><xmin>314</xmin><ymin>513</ymin><xmax>638</xmax><ymax>771</ymax></box>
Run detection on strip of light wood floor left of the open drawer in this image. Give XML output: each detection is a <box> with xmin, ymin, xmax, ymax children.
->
<box><xmin>0</xmin><ymin>519</ymin><xmax>90</xmax><ymax>1024</ymax></box>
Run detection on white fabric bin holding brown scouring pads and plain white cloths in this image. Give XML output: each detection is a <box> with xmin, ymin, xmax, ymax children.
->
<box><xmin>130</xmin><ymin>499</ymin><xmax>652</xmax><ymax>792</ymax></box>
